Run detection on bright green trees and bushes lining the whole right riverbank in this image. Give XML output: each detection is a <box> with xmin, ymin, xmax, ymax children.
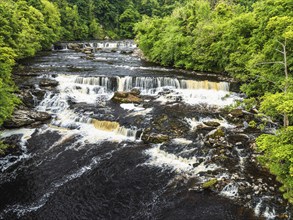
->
<box><xmin>135</xmin><ymin>0</ymin><xmax>293</xmax><ymax>202</ymax></box>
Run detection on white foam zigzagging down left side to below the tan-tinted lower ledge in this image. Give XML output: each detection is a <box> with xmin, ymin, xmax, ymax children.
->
<box><xmin>37</xmin><ymin>75</ymin><xmax>137</xmax><ymax>143</ymax></box>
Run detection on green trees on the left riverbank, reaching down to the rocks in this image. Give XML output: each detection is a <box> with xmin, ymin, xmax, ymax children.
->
<box><xmin>0</xmin><ymin>0</ymin><xmax>60</xmax><ymax>125</ymax></box>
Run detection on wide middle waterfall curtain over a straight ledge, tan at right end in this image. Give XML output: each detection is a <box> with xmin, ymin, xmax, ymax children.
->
<box><xmin>74</xmin><ymin>76</ymin><xmax>237</xmax><ymax>106</ymax></box>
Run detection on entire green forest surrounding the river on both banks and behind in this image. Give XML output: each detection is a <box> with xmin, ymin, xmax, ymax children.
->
<box><xmin>0</xmin><ymin>0</ymin><xmax>293</xmax><ymax>203</ymax></box>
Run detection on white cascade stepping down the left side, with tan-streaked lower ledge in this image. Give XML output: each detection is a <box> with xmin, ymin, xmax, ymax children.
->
<box><xmin>37</xmin><ymin>76</ymin><xmax>137</xmax><ymax>140</ymax></box>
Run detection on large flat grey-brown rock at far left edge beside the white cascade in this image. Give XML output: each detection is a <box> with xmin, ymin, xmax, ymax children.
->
<box><xmin>4</xmin><ymin>109</ymin><xmax>51</xmax><ymax>128</ymax></box>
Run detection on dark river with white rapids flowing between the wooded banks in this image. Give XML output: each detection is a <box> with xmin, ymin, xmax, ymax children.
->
<box><xmin>0</xmin><ymin>42</ymin><xmax>290</xmax><ymax>220</ymax></box>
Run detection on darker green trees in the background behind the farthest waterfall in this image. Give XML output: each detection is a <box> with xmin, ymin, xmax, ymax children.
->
<box><xmin>48</xmin><ymin>0</ymin><xmax>185</xmax><ymax>40</ymax></box>
